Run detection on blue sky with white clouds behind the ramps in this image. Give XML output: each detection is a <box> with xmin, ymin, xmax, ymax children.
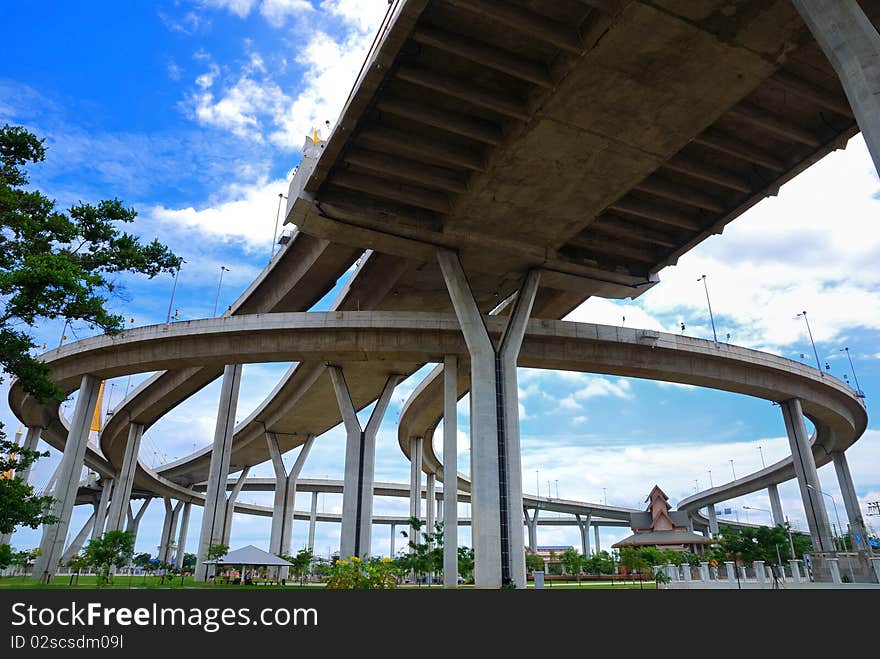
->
<box><xmin>0</xmin><ymin>0</ymin><xmax>880</xmax><ymax>554</ymax></box>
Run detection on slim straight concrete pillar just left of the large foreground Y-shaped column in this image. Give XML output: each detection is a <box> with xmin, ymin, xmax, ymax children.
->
<box><xmin>443</xmin><ymin>355</ymin><xmax>458</xmax><ymax>588</ymax></box>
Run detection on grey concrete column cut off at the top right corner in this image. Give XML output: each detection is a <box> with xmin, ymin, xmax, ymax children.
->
<box><xmin>792</xmin><ymin>0</ymin><xmax>880</xmax><ymax>172</ymax></box>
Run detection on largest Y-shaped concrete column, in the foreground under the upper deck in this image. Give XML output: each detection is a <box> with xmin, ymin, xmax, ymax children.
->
<box><xmin>437</xmin><ymin>250</ymin><xmax>540</xmax><ymax>588</ymax></box>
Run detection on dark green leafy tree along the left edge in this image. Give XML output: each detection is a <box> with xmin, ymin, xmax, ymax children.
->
<box><xmin>0</xmin><ymin>124</ymin><xmax>181</xmax><ymax>533</ymax></box>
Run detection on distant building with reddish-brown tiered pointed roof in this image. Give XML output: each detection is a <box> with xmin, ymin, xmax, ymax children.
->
<box><xmin>611</xmin><ymin>485</ymin><xmax>713</xmax><ymax>553</ymax></box>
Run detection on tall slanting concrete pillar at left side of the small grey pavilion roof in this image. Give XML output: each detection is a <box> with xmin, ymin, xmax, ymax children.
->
<box><xmin>195</xmin><ymin>364</ymin><xmax>241</xmax><ymax>581</ymax></box>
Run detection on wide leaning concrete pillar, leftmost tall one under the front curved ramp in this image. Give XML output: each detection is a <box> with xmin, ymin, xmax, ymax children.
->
<box><xmin>33</xmin><ymin>375</ymin><xmax>101</xmax><ymax>581</ymax></box>
